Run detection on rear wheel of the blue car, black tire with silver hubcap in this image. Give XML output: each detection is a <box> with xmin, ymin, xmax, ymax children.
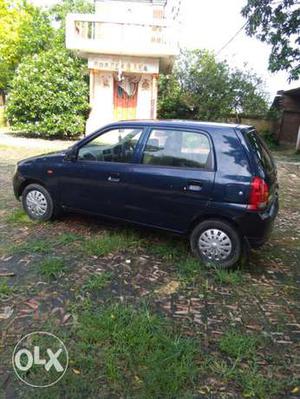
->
<box><xmin>190</xmin><ymin>219</ymin><xmax>242</xmax><ymax>269</ymax></box>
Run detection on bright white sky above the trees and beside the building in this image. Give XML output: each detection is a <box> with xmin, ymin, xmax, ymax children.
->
<box><xmin>31</xmin><ymin>0</ymin><xmax>300</xmax><ymax>100</ymax></box>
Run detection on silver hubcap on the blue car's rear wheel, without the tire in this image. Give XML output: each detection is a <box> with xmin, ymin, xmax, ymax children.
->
<box><xmin>198</xmin><ymin>229</ymin><xmax>232</xmax><ymax>261</ymax></box>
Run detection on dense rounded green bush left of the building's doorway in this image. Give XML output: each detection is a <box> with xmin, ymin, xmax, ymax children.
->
<box><xmin>7</xmin><ymin>48</ymin><xmax>89</xmax><ymax>138</ymax></box>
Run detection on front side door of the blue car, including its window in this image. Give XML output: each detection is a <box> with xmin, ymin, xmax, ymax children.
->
<box><xmin>60</xmin><ymin>127</ymin><xmax>143</xmax><ymax>218</ymax></box>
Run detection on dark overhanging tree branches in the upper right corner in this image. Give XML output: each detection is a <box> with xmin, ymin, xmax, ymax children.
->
<box><xmin>242</xmin><ymin>0</ymin><xmax>300</xmax><ymax>81</ymax></box>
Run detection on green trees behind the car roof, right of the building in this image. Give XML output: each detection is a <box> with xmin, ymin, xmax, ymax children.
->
<box><xmin>159</xmin><ymin>50</ymin><xmax>268</xmax><ymax>120</ymax></box>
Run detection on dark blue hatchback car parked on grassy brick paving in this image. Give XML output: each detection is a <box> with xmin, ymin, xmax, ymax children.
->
<box><xmin>13</xmin><ymin>121</ymin><xmax>278</xmax><ymax>268</ymax></box>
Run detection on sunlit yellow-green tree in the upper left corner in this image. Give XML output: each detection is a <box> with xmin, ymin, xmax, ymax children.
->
<box><xmin>0</xmin><ymin>0</ymin><xmax>54</xmax><ymax>94</ymax></box>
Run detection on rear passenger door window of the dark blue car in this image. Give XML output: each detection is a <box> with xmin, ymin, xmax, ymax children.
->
<box><xmin>143</xmin><ymin>129</ymin><xmax>212</xmax><ymax>169</ymax></box>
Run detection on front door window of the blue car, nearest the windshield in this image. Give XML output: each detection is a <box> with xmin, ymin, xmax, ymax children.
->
<box><xmin>78</xmin><ymin>128</ymin><xmax>143</xmax><ymax>163</ymax></box>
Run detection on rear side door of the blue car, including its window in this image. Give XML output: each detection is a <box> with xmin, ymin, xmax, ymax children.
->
<box><xmin>127</xmin><ymin>128</ymin><xmax>215</xmax><ymax>232</ymax></box>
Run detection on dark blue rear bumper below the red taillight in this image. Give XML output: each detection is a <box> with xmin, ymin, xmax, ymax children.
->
<box><xmin>239</xmin><ymin>197</ymin><xmax>279</xmax><ymax>248</ymax></box>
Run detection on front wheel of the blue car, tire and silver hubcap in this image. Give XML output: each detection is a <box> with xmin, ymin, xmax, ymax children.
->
<box><xmin>22</xmin><ymin>184</ymin><xmax>55</xmax><ymax>222</ymax></box>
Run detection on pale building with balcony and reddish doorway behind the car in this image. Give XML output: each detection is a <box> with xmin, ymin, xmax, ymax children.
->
<box><xmin>66</xmin><ymin>0</ymin><xmax>181</xmax><ymax>132</ymax></box>
